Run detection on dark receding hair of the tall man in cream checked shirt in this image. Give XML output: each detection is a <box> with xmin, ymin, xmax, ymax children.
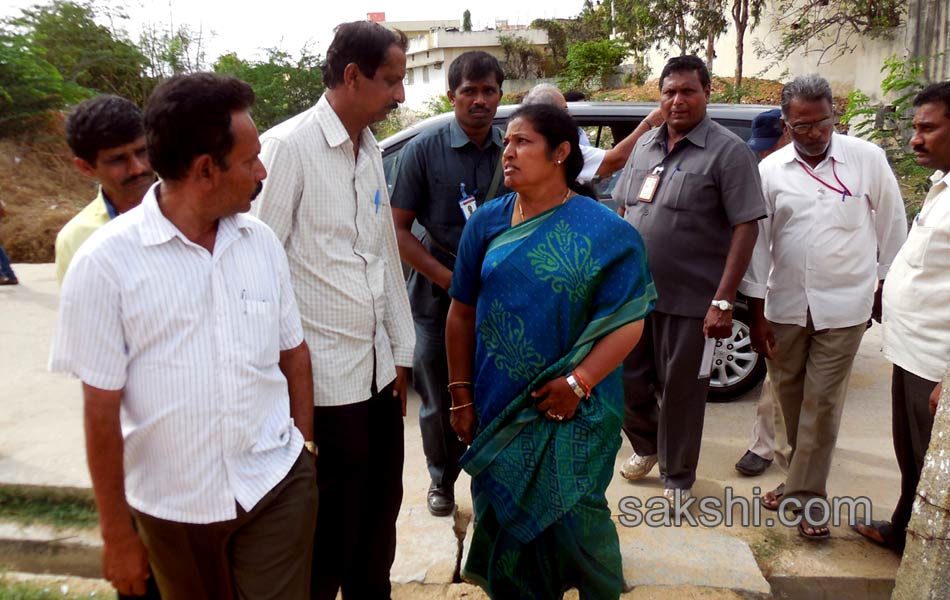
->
<box><xmin>320</xmin><ymin>21</ymin><xmax>409</xmax><ymax>88</ymax></box>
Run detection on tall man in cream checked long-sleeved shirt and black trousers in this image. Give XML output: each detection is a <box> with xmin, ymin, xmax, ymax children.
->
<box><xmin>254</xmin><ymin>21</ymin><xmax>415</xmax><ymax>600</ymax></box>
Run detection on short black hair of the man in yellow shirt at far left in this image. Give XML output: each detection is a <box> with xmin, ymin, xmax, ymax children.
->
<box><xmin>66</xmin><ymin>94</ymin><xmax>145</xmax><ymax>166</ymax></box>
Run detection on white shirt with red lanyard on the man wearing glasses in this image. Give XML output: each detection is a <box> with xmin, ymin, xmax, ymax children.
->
<box><xmin>739</xmin><ymin>133</ymin><xmax>907</xmax><ymax>329</ymax></box>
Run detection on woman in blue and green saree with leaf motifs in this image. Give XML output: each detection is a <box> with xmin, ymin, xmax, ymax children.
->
<box><xmin>446</xmin><ymin>105</ymin><xmax>656</xmax><ymax>600</ymax></box>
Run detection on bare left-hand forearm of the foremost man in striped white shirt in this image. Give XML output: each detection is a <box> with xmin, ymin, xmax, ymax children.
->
<box><xmin>82</xmin><ymin>383</ymin><xmax>135</xmax><ymax>541</ymax></box>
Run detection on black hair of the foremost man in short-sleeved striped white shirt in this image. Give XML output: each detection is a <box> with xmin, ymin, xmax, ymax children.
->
<box><xmin>145</xmin><ymin>73</ymin><xmax>254</xmax><ymax>181</ymax></box>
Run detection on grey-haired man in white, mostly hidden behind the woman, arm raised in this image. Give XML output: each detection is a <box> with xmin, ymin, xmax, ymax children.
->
<box><xmin>521</xmin><ymin>83</ymin><xmax>663</xmax><ymax>183</ymax></box>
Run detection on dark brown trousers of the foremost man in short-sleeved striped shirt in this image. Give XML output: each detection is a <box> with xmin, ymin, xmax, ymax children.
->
<box><xmin>132</xmin><ymin>451</ymin><xmax>317</xmax><ymax>600</ymax></box>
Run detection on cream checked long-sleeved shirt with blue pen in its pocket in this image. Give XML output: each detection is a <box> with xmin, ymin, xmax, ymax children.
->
<box><xmin>252</xmin><ymin>96</ymin><xmax>415</xmax><ymax>406</ymax></box>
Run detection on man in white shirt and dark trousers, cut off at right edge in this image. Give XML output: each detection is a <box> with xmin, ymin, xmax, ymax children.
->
<box><xmin>854</xmin><ymin>81</ymin><xmax>950</xmax><ymax>554</ymax></box>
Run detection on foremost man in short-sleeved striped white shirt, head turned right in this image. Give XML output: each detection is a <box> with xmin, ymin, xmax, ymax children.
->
<box><xmin>50</xmin><ymin>73</ymin><xmax>317</xmax><ymax>600</ymax></box>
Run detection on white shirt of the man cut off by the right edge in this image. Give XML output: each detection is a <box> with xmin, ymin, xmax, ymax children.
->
<box><xmin>883</xmin><ymin>171</ymin><xmax>950</xmax><ymax>381</ymax></box>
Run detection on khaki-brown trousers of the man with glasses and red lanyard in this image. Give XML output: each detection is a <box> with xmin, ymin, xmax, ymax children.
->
<box><xmin>762</xmin><ymin>316</ymin><xmax>867</xmax><ymax>502</ymax></box>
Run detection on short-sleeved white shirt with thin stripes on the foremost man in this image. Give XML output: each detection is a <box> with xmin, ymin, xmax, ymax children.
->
<box><xmin>50</xmin><ymin>184</ymin><xmax>303</xmax><ymax>523</ymax></box>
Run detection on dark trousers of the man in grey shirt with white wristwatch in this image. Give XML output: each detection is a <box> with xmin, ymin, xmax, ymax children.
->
<box><xmin>623</xmin><ymin>311</ymin><xmax>709</xmax><ymax>489</ymax></box>
